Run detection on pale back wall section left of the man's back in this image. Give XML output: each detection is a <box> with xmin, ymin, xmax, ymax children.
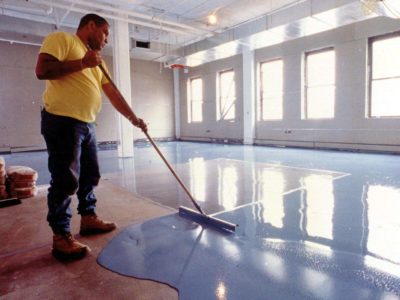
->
<box><xmin>0</xmin><ymin>42</ymin><xmax>45</xmax><ymax>151</ymax></box>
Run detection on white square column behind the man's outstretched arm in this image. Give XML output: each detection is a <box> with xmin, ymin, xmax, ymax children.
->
<box><xmin>112</xmin><ymin>21</ymin><xmax>133</xmax><ymax>157</ymax></box>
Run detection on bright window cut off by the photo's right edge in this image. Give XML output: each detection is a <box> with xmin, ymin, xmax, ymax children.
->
<box><xmin>368</xmin><ymin>33</ymin><xmax>400</xmax><ymax>117</ymax></box>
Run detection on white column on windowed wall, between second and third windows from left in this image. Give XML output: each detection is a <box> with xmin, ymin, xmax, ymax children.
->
<box><xmin>242</xmin><ymin>51</ymin><xmax>255</xmax><ymax>145</ymax></box>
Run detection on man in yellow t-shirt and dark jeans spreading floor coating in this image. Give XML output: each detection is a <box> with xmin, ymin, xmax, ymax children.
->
<box><xmin>36</xmin><ymin>14</ymin><xmax>147</xmax><ymax>259</ymax></box>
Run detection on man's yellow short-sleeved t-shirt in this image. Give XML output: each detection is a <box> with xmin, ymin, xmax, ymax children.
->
<box><xmin>40</xmin><ymin>32</ymin><xmax>108</xmax><ymax>123</ymax></box>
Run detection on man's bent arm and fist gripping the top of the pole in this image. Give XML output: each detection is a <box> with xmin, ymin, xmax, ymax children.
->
<box><xmin>35</xmin><ymin>50</ymin><xmax>101</xmax><ymax>80</ymax></box>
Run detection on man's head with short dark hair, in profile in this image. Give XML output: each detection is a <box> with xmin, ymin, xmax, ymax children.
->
<box><xmin>77</xmin><ymin>14</ymin><xmax>110</xmax><ymax>51</ymax></box>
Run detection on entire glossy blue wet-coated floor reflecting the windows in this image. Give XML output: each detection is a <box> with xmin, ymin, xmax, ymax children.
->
<box><xmin>4</xmin><ymin>142</ymin><xmax>400</xmax><ymax>299</ymax></box>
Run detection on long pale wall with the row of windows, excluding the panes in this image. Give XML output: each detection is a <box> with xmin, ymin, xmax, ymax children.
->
<box><xmin>181</xmin><ymin>17</ymin><xmax>400</xmax><ymax>152</ymax></box>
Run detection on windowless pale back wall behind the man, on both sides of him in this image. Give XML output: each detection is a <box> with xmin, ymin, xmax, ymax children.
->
<box><xmin>0</xmin><ymin>42</ymin><xmax>174</xmax><ymax>151</ymax></box>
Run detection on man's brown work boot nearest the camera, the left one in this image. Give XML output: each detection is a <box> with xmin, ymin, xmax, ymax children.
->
<box><xmin>52</xmin><ymin>233</ymin><xmax>90</xmax><ymax>260</ymax></box>
